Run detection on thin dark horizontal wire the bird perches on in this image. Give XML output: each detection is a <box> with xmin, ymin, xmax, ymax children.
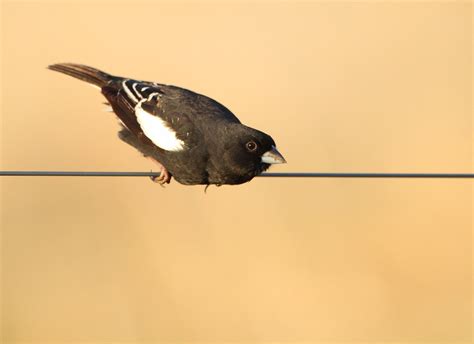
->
<box><xmin>0</xmin><ymin>171</ymin><xmax>474</xmax><ymax>179</ymax></box>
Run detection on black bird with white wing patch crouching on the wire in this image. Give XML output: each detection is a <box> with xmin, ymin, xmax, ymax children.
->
<box><xmin>48</xmin><ymin>63</ymin><xmax>286</xmax><ymax>188</ymax></box>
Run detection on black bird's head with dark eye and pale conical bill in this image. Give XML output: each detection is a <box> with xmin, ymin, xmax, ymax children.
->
<box><xmin>222</xmin><ymin>124</ymin><xmax>286</xmax><ymax>177</ymax></box>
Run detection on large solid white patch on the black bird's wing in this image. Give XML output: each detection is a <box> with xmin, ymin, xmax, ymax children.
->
<box><xmin>135</xmin><ymin>101</ymin><xmax>185</xmax><ymax>152</ymax></box>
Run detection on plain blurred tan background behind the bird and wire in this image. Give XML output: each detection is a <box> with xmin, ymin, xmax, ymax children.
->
<box><xmin>1</xmin><ymin>1</ymin><xmax>473</xmax><ymax>343</ymax></box>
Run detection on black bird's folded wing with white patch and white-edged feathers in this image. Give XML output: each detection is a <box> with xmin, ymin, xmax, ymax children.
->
<box><xmin>102</xmin><ymin>79</ymin><xmax>193</xmax><ymax>152</ymax></box>
